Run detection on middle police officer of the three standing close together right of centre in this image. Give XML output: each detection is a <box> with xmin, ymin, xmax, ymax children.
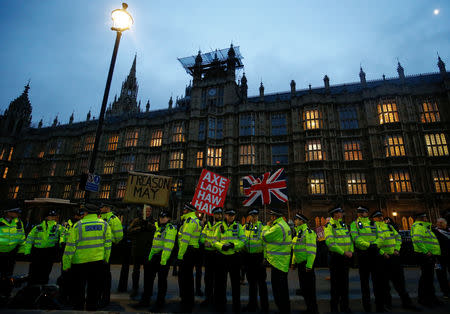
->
<box><xmin>350</xmin><ymin>206</ymin><xmax>385</xmax><ymax>312</ymax></box>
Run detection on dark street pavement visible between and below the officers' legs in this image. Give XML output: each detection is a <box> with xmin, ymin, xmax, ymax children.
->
<box><xmin>3</xmin><ymin>262</ymin><xmax>450</xmax><ymax>314</ymax></box>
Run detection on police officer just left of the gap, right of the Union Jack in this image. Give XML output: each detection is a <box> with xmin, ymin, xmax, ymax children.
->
<box><xmin>292</xmin><ymin>213</ymin><xmax>319</xmax><ymax>313</ymax></box>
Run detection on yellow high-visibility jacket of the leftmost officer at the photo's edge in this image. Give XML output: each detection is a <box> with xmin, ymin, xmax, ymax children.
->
<box><xmin>0</xmin><ymin>218</ymin><xmax>25</xmax><ymax>253</ymax></box>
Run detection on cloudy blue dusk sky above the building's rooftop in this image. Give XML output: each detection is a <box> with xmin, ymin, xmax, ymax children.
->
<box><xmin>0</xmin><ymin>0</ymin><xmax>450</xmax><ymax>125</ymax></box>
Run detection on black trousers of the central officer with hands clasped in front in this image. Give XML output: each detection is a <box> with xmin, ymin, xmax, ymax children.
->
<box><xmin>214</xmin><ymin>253</ymin><xmax>241</xmax><ymax>312</ymax></box>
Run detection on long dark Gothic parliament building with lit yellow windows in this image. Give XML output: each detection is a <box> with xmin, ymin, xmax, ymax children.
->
<box><xmin>0</xmin><ymin>45</ymin><xmax>450</xmax><ymax>228</ymax></box>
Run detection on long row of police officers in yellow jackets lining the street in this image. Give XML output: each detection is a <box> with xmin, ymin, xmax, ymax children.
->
<box><xmin>0</xmin><ymin>203</ymin><xmax>450</xmax><ymax>313</ymax></box>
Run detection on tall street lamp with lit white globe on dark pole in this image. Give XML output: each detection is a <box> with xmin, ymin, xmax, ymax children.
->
<box><xmin>85</xmin><ymin>3</ymin><xmax>133</xmax><ymax>200</ymax></box>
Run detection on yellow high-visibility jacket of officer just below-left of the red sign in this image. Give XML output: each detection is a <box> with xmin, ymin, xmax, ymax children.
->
<box><xmin>178</xmin><ymin>212</ymin><xmax>202</xmax><ymax>259</ymax></box>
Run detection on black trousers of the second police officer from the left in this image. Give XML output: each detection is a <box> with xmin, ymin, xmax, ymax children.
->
<box><xmin>28</xmin><ymin>247</ymin><xmax>58</xmax><ymax>285</ymax></box>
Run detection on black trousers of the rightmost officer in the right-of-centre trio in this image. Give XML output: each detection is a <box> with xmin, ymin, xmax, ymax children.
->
<box><xmin>383</xmin><ymin>255</ymin><xmax>412</xmax><ymax>306</ymax></box>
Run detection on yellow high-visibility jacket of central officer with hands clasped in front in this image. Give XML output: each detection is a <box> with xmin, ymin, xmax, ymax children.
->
<box><xmin>214</xmin><ymin>221</ymin><xmax>245</xmax><ymax>255</ymax></box>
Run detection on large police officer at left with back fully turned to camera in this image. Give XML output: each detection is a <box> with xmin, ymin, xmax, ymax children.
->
<box><xmin>63</xmin><ymin>203</ymin><xmax>112</xmax><ymax>311</ymax></box>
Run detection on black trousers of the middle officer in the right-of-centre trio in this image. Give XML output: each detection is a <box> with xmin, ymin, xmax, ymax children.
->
<box><xmin>356</xmin><ymin>249</ymin><xmax>385</xmax><ymax>312</ymax></box>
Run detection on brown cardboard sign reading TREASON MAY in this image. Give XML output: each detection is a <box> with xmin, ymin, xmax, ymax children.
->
<box><xmin>123</xmin><ymin>172</ymin><xmax>172</xmax><ymax>207</ymax></box>
